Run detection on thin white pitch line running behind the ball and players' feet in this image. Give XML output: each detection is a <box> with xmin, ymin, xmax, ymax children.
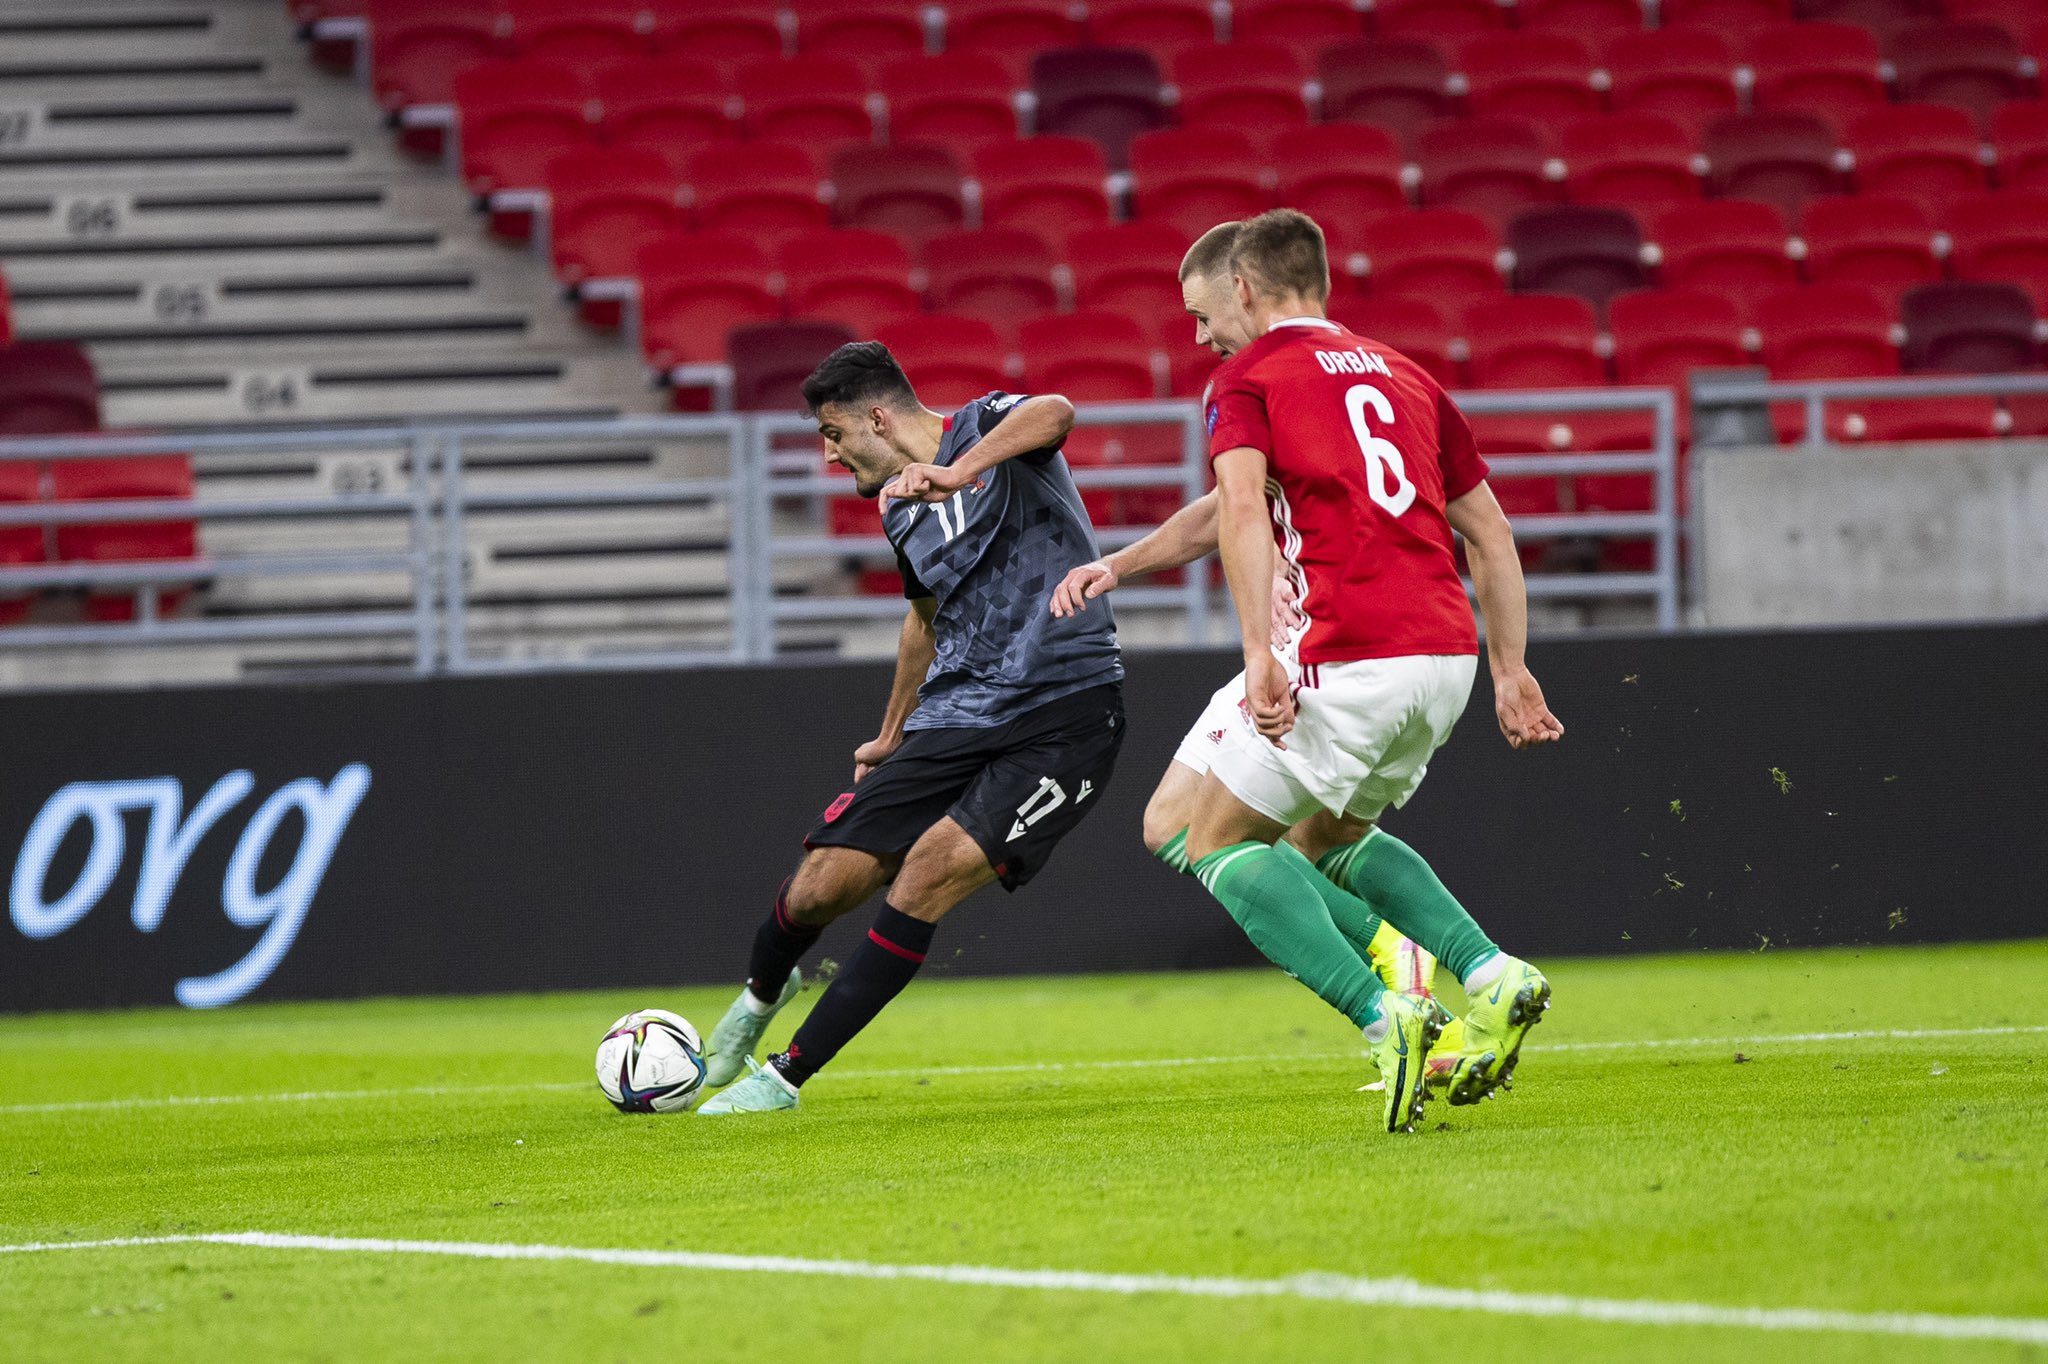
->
<box><xmin>0</xmin><ymin>1024</ymin><xmax>2048</xmax><ymax>1118</ymax></box>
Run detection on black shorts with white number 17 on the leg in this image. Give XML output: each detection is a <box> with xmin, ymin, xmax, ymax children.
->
<box><xmin>803</xmin><ymin>682</ymin><xmax>1124</xmax><ymax>891</ymax></box>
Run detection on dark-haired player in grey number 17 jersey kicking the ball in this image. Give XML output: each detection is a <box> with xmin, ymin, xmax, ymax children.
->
<box><xmin>702</xmin><ymin>342</ymin><xmax>1124</xmax><ymax>1114</ymax></box>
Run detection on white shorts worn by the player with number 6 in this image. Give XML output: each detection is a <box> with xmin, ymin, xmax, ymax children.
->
<box><xmin>1204</xmin><ymin>653</ymin><xmax>1479</xmax><ymax>825</ymax></box>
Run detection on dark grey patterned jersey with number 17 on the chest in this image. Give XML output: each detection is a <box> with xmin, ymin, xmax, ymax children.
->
<box><xmin>883</xmin><ymin>393</ymin><xmax>1124</xmax><ymax>729</ymax></box>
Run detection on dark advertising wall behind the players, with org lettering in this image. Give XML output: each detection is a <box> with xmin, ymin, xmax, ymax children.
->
<box><xmin>0</xmin><ymin>625</ymin><xmax>2048</xmax><ymax>1010</ymax></box>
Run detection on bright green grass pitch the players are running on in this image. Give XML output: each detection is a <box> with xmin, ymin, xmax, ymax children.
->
<box><xmin>0</xmin><ymin>942</ymin><xmax>2048</xmax><ymax>1364</ymax></box>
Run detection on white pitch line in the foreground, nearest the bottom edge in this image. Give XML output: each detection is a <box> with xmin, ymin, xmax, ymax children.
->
<box><xmin>0</xmin><ymin>1231</ymin><xmax>2048</xmax><ymax>1346</ymax></box>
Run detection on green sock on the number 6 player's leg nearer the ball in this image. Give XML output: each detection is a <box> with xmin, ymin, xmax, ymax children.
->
<box><xmin>1194</xmin><ymin>842</ymin><xmax>1384</xmax><ymax>1028</ymax></box>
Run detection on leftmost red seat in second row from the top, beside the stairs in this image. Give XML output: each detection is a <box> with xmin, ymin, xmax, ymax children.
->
<box><xmin>455</xmin><ymin>61</ymin><xmax>598</xmax><ymax>195</ymax></box>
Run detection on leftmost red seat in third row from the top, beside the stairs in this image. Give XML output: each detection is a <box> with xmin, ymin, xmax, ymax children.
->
<box><xmin>545</xmin><ymin>147</ymin><xmax>684</xmax><ymax>285</ymax></box>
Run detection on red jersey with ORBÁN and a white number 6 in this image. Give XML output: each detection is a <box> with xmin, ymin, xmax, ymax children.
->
<box><xmin>1208</xmin><ymin>317</ymin><xmax>1487</xmax><ymax>664</ymax></box>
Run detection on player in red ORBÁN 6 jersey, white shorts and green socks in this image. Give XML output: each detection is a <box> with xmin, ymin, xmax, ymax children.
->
<box><xmin>1188</xmin><ymin>209</ymin><xmax>1565</xmax><ymax>1131</ymax></box>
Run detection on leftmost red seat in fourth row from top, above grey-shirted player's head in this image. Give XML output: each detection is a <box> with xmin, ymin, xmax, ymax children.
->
<box><xmin>633</xmin><ymin>231</ymin><xmax>782</xmax><ymax>371</ymax></box>
